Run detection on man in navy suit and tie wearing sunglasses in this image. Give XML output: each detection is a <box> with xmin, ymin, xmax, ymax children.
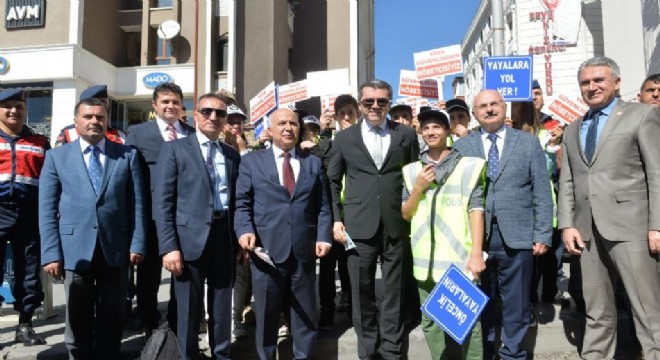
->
<box><xmin>153</xmin><ymin>94</ymin><xmax>241</xmax><ymax>359</ymax></box>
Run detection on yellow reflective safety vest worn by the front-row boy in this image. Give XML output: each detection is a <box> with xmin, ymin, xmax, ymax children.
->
<box><xmin>403</xmin><ymin>157</ymin><xmax>486</xmax><ymax>282</ymax></box>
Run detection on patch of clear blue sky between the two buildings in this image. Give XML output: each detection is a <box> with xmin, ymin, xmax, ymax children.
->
<box><xmin>374</xmin><ymin>0</ymin><xmax>480</xmax><ymax>100</ymax></box>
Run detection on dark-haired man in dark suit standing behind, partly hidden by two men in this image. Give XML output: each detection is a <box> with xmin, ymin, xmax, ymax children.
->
<box><xmin>126</xmin><ymin>83</ymin><xmax>195</xmax><ymax>337</ymax></box>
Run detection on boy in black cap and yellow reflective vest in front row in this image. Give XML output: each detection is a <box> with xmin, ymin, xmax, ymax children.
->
<box><xmin>401</xmin><ymin>110</ymin><xmax>486</xmax><ymax>359</ymax></box>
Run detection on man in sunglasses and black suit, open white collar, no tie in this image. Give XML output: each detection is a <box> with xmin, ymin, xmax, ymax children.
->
<box><xmin>328</xmin><ymin>80</ymin><xmax>419</xmax><ymax>360</ymax></box>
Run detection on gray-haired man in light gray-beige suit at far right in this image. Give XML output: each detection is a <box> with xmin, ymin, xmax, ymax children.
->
<box><xmin>558</xmin><ymin>57</ymin><xmax>660</xmax><ymax>359</ymax></box>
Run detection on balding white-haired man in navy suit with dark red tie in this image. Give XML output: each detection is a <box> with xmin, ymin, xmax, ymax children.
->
<box><xmin>234</xmin><ymin>109</ymin><xmax>332</xmax><ymax>360</ymax></box>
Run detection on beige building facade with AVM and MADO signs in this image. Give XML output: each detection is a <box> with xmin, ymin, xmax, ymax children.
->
<box><xmin>0</xmin><ymin>0</ymin><xmax>374</xmax><ymax>139</ymax></box>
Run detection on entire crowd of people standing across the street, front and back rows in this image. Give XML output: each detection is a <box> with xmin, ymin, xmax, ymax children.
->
<box><xmin>0</xmin><ymin>57</ymin><xmax>660</xmax><ymax>360</ymax></box>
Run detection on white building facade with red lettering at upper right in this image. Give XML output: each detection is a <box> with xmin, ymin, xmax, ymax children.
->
<box><xmin>461</xmin><ymin>0</ymin><xmax>660</xmax><ymax>115</ymax></box>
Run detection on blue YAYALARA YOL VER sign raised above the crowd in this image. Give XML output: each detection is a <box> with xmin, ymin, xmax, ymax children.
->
<box><xmin>484</xmin><ymin>55</ymin><xmax>534</xmax><ymax>101</ymax></box>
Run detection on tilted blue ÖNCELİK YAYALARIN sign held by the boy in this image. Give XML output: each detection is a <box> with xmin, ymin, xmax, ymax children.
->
<box><xmin>422</xmin><ymin>264</ymin><xmax>488</xmax><ymax>344</ymax></box>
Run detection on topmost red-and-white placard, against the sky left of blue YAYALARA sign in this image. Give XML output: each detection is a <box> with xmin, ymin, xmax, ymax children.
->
<box><xmin>413</xmin><ymin>45</ymin><xmax>463</xmax><ymax>79</ymax></box>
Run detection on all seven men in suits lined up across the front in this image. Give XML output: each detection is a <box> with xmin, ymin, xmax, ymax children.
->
<box><xmin>28</xmin><ymin>57</ymin><xmax>660</xmax><ymax>359</ymax></box>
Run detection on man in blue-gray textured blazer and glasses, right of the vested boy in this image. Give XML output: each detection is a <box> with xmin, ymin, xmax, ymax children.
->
<box><xmin>454</xmin><ymin>90</ymin><xmax>553</xmax><ymax>360</ymax></box>
